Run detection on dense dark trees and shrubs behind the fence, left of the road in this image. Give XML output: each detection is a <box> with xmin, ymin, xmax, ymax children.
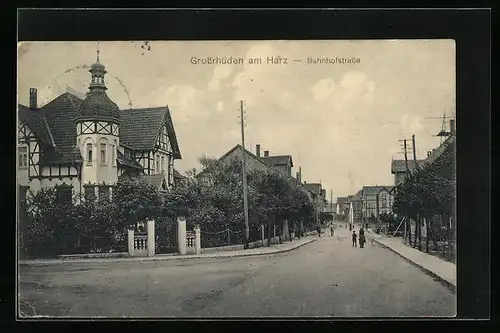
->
<box><xmin>19</xmin><ymin>156</ymin><xmax>315</xmax><ymax>257</ymax></box>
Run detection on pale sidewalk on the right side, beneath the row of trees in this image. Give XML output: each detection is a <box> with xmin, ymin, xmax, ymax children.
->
<box><xmin>367</xmin><ymin>230</ymin><xmax>457</xmax><ymax>288</ymax></box>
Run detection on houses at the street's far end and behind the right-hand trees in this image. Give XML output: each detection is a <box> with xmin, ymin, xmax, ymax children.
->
<box><xmin>335</xmin><ymin>120</ymin><xmax>456</xmax><ymax>223</ymax></box>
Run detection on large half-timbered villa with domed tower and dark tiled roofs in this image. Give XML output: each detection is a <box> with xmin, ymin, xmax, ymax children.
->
<box><xmin>18</xmin><ymin>54</ymin><xmax>181</xmax><ymax>200</ymax></box>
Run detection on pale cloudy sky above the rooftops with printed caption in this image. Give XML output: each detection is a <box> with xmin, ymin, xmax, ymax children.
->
<box><xmin>18</xmin><ymin>40</ymin><xmax>456</xmax><ymax>201</ymax></box>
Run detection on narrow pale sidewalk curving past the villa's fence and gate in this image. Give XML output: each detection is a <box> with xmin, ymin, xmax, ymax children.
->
<box><xmin>19</xmin><ymin>236</ymin><xmax>316</xmax><ymax>265</ymax></box>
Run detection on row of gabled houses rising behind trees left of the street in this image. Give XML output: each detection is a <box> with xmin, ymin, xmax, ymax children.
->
<box><xmin>196</xmin><ymin>144</ymin><xmax>328</xmax><ymax>222</ymax></box>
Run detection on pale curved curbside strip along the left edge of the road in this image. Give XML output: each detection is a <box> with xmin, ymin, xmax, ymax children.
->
<box><xmin>19</xmin><ymin>238</ymin><xmax>316</xmax><ymax>266</ymax></box>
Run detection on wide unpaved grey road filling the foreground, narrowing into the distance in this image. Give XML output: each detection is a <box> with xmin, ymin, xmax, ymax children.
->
<box><xmin>19</xmin><ymin>228</ymin><xmax>455</xmax><ymax>317</ymax></box>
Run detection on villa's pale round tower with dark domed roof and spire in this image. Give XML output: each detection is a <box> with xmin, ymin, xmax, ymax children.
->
<box><xmin>75</xmin><ymin>44</ymin><xmax>120</xmax><ymax>197</ymax></box>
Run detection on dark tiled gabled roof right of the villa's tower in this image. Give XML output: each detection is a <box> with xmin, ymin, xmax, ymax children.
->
<box><xmin>120</xmin><ymin>106</ymin><xmax>182</xmax><ymax>159</ymax></box>
